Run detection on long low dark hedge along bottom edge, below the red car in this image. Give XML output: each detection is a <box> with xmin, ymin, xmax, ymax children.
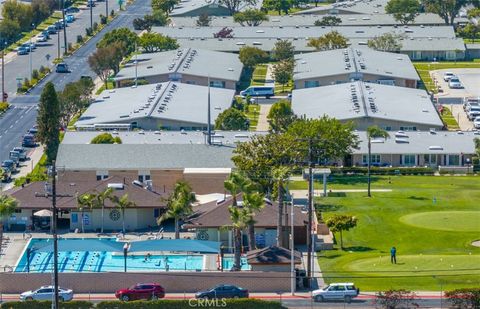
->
<box><xmin>1</xmin><ymin>298</ymin><xmax>285</xmax><ymax>309</ymax></box>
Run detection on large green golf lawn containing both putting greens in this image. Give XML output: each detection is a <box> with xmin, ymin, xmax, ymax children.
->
<box><xmin>312</xmin><ymin>176</ymin><xmax>480</xmax><ymax>291</ymax></box>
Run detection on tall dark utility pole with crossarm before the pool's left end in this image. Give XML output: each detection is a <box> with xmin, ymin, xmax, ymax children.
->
<box><xmin>35</xmin><ymin>160</ymin><xmax>72</xmax><ymax>309</ymax></box>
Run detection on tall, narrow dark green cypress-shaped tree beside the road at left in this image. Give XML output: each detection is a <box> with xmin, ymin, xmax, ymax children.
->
<box><xmin>37</xmin><ymin>82</ymin><xmax>60</xmax><ymax>164</ymax></box>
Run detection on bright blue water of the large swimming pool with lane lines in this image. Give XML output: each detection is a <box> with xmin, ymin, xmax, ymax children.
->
<box><xmin>15</xmin><ymin>239</ymin><xmax>204</xmax><ymax>272</ymax></box>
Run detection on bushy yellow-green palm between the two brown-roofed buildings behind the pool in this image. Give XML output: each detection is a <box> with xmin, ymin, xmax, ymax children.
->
<box><xmin>157</xmin><ymin>180</ymin><xmax>197</xmax><ymax>239</ymax></box>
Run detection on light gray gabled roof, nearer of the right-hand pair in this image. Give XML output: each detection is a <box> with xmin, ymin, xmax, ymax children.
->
<box><xmin>292</xmin><ymin>82</ymin><xmax>443</xmax><ymax>127</ymax></box>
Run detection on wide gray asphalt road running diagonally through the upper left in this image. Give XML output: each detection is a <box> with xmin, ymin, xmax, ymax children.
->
<box><xmin>0</xmin><ymin>0</ymin><xmax>150</xmax><ymax>161</ymax></box>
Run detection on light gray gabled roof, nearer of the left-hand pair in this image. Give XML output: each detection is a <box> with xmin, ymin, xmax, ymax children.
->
<box><xmin>75</xmin><ymin>82</ymin><xmax>235</xmax><ymax>126</ymax></box>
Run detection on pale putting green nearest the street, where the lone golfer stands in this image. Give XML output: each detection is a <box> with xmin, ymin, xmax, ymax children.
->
<box><xmin>348</xmin><ymin>251</ymin><xmax>480</xmax><ymax>276</ymax></box>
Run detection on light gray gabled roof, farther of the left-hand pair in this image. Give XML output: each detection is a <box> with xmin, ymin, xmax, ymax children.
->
<box><xmin>114</xmin><ymin>48</ymin><xmax>243</xmax><ymax>81</ymax></box>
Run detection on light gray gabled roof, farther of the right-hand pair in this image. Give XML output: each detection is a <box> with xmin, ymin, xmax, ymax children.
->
<box><xmin>294</xmin><ymin>48</ymin><xmax>420</xmax><ymax>80</ymax></box>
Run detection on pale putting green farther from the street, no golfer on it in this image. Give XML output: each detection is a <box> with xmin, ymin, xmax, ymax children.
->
<box><xmin>400</xmin><ymin>211</ymin><xmax>480</xmax><ymax>232</ymax></box>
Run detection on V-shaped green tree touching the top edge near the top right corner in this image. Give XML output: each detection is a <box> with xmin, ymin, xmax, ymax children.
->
<box><xmin>422</xmin><ymin>0</ymin><xmax>479</xmax><ymax>25</ymax></box>
